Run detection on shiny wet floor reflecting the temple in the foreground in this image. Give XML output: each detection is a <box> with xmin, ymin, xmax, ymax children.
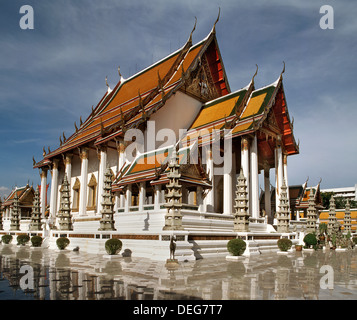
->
<box><xmin>0</xmin><ymin>245</ymin><xmax>357</xmax><ymax>300</ymax></box>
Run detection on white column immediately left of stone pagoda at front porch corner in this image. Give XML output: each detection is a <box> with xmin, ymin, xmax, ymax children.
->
<box><xmin>223</xmin><ymin>144</ymin><xmax>234</xmax><ymax>214</ymax></box>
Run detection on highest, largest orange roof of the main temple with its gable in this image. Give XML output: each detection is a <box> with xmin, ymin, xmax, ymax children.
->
<box><xmin>34</xmin><ymin>23</ymin><xmax>230</xmax><ymax>168</ymax></box>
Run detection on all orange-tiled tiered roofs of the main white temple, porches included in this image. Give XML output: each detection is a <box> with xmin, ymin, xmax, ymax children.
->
<box><xmin>34</xmin><ymin>19</ymin><xmax>299</xmax><ymax>198</ymax></box>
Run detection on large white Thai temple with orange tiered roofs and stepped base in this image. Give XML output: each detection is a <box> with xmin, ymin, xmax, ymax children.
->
<box><xmin>2</xmin><ymin>19</ymin><xmax>299</xmax><ymax>261</ymax></box>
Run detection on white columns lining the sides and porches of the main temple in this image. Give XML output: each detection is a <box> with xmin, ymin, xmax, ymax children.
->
<box><xmin>41</xmin><ymin>135</ymin><xmax>288</xmax><ymax>226</ymax></box>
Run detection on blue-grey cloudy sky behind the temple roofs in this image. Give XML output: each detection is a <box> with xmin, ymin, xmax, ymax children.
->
<box><xmin>0</xmin><ymin>0</ymin><xmax>357</xmax><ymax>196</ymax></box>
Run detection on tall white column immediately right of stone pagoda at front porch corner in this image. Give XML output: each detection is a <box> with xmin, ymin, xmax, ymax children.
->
<box><xmin>250</xmin><ymin>135</ymin><xmax>259</xmax><ymax>218</ymax></box>
